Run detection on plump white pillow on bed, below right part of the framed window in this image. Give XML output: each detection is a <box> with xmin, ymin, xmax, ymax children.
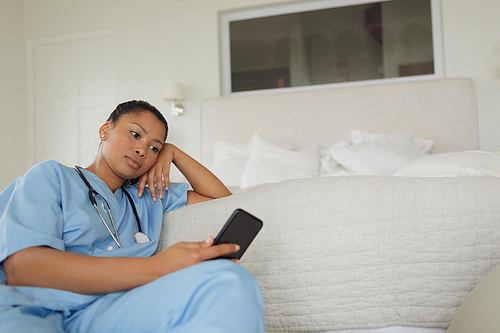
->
<box><xmin>330</xmin><ymin>133</ymin><xmax>425</xmax><ymax>176</ymax></box>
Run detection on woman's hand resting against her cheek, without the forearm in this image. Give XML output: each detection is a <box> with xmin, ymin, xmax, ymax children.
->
<box><xmin>137</xmin><ymin>143</ymin><xmax>175</xmax><ymax>201</ymax></box>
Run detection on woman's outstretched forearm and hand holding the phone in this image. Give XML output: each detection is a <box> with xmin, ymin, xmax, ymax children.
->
<box><xmin>4</xmin><ymin>237</ymin><xmax>239</xmax><ymax>294</ymax></box>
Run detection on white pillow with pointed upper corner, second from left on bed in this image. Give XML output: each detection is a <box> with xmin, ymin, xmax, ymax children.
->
<box><xmin>241</xmin><ymin>134</ymin><xmax>319</xmax><ymax>188</ymax></box>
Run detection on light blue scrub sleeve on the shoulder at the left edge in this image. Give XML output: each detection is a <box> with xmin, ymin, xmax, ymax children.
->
<box><xmin>0</xmin><ymin>163</ymin><xmax>65</xmax><ymax>262</ymax></box>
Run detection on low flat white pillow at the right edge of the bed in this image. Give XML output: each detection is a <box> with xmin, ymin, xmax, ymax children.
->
<box><xmin>394</xmin><ymin>150</ymin><xmax>500</xmax><ymax>177</ymax></box>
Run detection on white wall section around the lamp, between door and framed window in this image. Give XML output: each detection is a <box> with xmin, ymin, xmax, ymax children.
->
<box><xmin>17</xmin><ymin>0</ymin><xmax>292</xmax><ymax>184</ymax></box>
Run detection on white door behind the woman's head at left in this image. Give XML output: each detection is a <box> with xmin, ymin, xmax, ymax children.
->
<box><xmin>28</xmin><ymin>33</ymin><xmax>114</xmax><ymax>166</ymax></box>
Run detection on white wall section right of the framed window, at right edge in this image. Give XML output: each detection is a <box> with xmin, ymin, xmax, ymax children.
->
<box><xmin>441</xmin><ymin>0</ymin><xmax>500</xmax><ymax>151</ymax></box>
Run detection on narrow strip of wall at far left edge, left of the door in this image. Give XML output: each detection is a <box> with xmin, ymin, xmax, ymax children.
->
<box><xmin>0</xmin><ymin>0</ymin><xmax>27</xmax><ymax>191</ymax></box>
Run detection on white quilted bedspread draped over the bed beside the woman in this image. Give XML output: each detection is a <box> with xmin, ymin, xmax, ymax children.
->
<box><xmin>160</xmin><ymin>176</ymin><xmax>500</xmax><ymax>332</ymax></box>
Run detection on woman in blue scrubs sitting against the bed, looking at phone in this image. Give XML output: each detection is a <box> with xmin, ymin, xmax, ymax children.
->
<box><xmin>0</xmin><ymin>101</ymin><xmax>264</xmax><ymax>332</ymax></box>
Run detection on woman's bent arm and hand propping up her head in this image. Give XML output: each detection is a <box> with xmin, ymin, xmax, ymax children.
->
<box><xmin>139</xmin><ymin>143</ymin><xmax>231</xmax><ymax>205</ymax></box>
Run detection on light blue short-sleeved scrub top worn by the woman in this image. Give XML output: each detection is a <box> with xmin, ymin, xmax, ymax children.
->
<box><xmin>0</xmin><ymin>161</ymin><xmax>189</xmax><ymax>311</ymax></box>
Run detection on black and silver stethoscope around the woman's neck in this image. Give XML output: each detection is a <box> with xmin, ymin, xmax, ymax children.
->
<box><xmin>75</xmin><ymin>165</ymin><xmax>151</xmax><ymax>248</ymax></box>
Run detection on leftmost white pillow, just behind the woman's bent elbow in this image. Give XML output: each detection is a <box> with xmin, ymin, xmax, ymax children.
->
<box><xmin>210</xmin><ymin>141</ymin><xmax>250</xmax><ymax>187</ymax></box>
